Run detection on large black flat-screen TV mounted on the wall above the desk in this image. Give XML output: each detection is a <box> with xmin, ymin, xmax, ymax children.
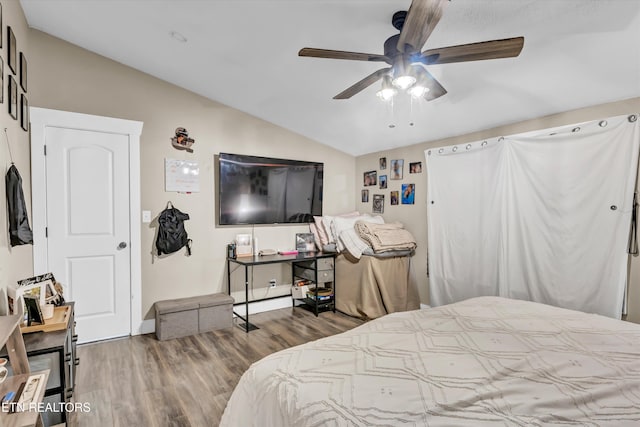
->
<box><xmin>218</xmin><ymin>153</ymin><xmax>324</xmax><ymax>225</ymax></box>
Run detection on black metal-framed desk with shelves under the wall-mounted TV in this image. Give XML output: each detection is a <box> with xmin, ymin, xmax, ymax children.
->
<box><xmin>227</xmin><ymin>252</ymin><xmax>336</xmax><ymax>333</ymax></box>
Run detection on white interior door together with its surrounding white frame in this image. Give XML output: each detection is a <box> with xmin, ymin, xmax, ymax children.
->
<box><xmin>29</xmin><ymin>107</ymin><xmax>143</xmax><ymax>342</ymax></box>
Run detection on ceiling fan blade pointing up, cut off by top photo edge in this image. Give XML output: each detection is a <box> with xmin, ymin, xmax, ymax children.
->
<box><xmin>398</xmin><ymin>0</ymin><xmax>447</xmax><ymax>52</ymax></box>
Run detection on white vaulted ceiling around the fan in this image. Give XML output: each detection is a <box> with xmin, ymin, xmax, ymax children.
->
<box><xmin>20</xmin><ymin>0</ymin><xmax>640</xmax><ymax>155</ymax></box>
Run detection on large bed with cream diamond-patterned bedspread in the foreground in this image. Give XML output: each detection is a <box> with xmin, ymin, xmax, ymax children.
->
<box><xmin>221</xmin><ymin>297</ymin><xmax>640</xmax><ymax>427</ymax></box>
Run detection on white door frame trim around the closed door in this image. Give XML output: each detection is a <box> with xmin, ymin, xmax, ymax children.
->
<box><xmin>29</xmin><ymin>107</ymin><xmax>143</xmax><ymax>335</ymax></box>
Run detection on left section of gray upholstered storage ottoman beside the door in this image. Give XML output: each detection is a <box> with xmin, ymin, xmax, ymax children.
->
<box><xmin>155</xmin><ymin>298</ymin><xmax>200</xmax><ymax>341</ymax></box>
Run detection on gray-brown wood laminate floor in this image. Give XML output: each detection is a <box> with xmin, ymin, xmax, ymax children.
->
<box><xmin>68</xmin><ymin>308</ymin><xmax>363</xmax><ymax>427</ymax></box>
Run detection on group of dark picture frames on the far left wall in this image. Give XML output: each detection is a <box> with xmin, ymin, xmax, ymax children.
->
<box><xmin>0</xmin><ymin>3</ymin><xmax>29</xmax><ymax>131</ymax></box>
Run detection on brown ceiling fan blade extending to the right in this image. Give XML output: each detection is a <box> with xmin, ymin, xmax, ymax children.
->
<box><xmin>422</xmin><ymin>37</ymin><xmax>524</xmax><ymax>64</ymax></box>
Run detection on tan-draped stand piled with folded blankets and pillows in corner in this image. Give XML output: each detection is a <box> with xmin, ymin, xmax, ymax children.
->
<box><xmin>309</xmin><ymin>212</ymin><xmax>420</xmax><ymax>319</ymax></box>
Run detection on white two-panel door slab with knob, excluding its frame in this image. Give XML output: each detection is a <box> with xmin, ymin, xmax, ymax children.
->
<box><xmin>45</xmin><ymin>127</ymin><xmax>131</xmax><ymax>341</ymax></box>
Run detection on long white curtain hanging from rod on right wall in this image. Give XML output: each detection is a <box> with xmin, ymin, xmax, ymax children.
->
<box><xmin>425</xmin><ymin>116</ymin><xmax>640</xmax><ymax>318</ymax></box>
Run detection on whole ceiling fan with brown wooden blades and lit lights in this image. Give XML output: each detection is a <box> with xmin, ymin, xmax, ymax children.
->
<box><xmin>298</xmin><ymin>0</ymin><xmax>524</xmax><ymax>101</ymax></box>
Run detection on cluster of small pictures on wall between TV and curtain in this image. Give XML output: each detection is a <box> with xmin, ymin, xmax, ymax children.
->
<box><xmin>361</xmin><ymin>157</ymin><xmax>422</xmax><ymax>214</ymax></box>
